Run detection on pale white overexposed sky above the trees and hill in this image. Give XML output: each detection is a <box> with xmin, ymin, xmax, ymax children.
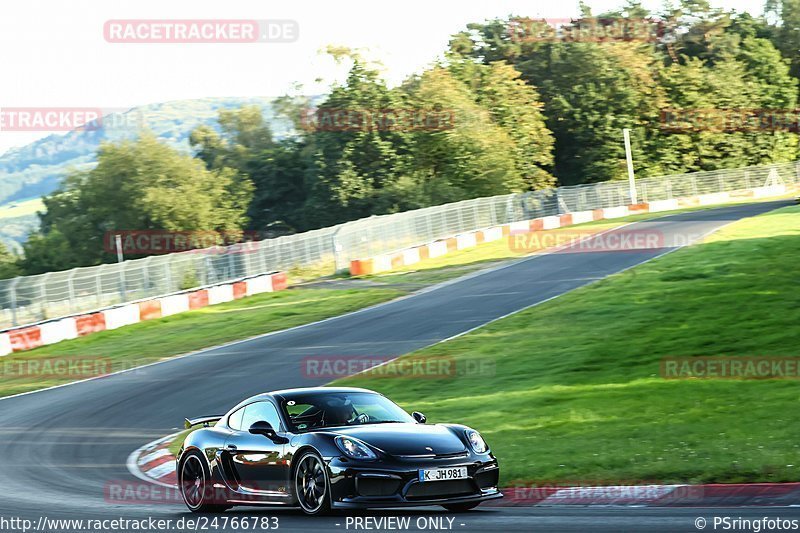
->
<box><xmin>0</xmin><ymin>0</ymin><xmax>763</xmax><ymax>154</ymax></box>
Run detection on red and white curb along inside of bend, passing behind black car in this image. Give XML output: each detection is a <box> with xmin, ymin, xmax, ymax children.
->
<box><xmin>128</xmin><ymin>433</ymin><xmax>800</xmax><ymax>507</ymax></box>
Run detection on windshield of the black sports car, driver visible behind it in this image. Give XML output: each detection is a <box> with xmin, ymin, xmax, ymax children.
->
<box><xmin>281</xmin><ymin>392</ymin><xmax>414</xmax><ymax>432</ymax></box>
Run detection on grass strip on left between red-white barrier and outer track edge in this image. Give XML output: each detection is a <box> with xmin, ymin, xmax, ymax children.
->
<box><xmin>0</xmin><ymin>289</ymin><xmax>403</xmax><ymax>396</ymax></box>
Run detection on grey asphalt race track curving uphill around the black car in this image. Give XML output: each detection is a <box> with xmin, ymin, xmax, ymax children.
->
<box><xmin>0</xmin><ymin>201</ymin><xmax>800</xmax><ymax>531</ymax></box>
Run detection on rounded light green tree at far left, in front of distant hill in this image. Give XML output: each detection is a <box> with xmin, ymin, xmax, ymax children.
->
<box><xmin>22</xmin><ymin>133</ymin><xmax>252</xmax><ymax>274</ymax></box>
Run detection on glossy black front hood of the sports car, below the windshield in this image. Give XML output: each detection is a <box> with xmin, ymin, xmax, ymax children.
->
<box><xmin>334</xmin><ymin>424</ymin><xmax>467</xmax><ymax>455</ymax></box>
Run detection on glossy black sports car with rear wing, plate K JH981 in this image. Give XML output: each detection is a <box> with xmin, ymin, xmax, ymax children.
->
<box><xmin>177</xmin><ymin>387</ymin><xmax>502</xmax><ymax>515</ymax></box>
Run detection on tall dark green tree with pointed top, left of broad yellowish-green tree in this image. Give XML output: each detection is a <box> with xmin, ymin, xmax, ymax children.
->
<box><xmin>305</xmin><ymin>58</ymin><xmax>416</xmax><ymax>226</ymax></box>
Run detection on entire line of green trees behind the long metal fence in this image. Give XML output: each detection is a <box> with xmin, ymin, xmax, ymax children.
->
<box><xmin>0</xmin><ymin>0</ymin><xmax>800</xmax><ymax>275</ymax></box>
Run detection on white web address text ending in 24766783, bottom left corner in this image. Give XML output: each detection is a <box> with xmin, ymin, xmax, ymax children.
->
<box><xmin>0</xmin><ymin>515</ymin><xmax>280</xmax><ymax>533</ymax></box>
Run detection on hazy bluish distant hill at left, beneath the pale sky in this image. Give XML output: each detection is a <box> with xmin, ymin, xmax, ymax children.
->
<box><xmin>0</xmin><ymin>97</ymin><xmax>298</xmax><ymax>248</ymax></box>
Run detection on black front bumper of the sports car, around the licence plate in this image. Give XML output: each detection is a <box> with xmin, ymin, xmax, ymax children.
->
<box><xmin>328</xmin><ymin>454</ymin><xmax>503</xmax><ymax>509</ymax></box>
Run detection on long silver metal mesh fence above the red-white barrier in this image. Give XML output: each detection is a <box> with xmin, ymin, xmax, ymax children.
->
<box><xmin>0</xmin><ymin>162</ymin><xmax>800</xmax><ymax>329</ymax></box>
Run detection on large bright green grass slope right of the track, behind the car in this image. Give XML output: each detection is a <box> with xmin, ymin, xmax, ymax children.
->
<box><xmin>337</xmin><ymin>207</ymin><xmax>800</xmax><ymax>485</ymax></box>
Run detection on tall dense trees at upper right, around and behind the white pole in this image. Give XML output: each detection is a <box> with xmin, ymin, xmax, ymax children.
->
<box><xmin>450</xmin><ymin>8</ymin><xmax>800</xmax><ymax>184</ymax></box>
